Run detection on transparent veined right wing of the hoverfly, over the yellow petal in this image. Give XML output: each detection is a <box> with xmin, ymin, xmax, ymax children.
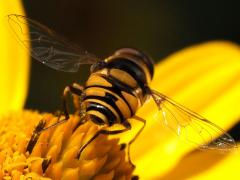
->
<box><xmin>151</xmin><ymin>90</ymin><xmax>237</xmax><ymax>151</ymax></box>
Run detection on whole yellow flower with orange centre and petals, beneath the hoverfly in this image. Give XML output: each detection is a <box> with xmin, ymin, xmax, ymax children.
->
<box><xmin>0</xmin><ymin>1</ymin><xmax>240</xmax><ymax>179</ymax></box>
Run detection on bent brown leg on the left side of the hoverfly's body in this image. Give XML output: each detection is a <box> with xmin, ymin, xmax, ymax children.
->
<box><xmin>40</xmin><ymin>84</ymin><xmax>83</xmax><ymax>132</ymax></box>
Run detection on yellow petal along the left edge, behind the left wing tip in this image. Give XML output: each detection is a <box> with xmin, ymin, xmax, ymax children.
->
<box><xmin>0</xmin><ymin>0</ymin><xmax>29</xmax><ymax>114</ymax></box>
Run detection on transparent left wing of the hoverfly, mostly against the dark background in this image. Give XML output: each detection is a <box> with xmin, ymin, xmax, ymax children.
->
<box><xmin>8</xmin><ymin>14</ymin><xmax>98</xmax><ymax>72</ymax></box>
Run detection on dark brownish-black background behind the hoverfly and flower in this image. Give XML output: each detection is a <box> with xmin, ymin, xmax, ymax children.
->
<box><xmin>21</xmin><ymin>0</ymin><xmax>240</xmax><ymax>137</ymax></box>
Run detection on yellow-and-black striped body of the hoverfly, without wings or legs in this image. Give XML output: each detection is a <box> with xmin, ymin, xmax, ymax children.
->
<box><xmin>83</xmin><ymin>49</ymin><xmax>152</xmax><ymax>126</ymax></box>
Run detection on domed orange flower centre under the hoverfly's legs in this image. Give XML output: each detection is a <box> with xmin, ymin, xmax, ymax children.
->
<box><xmin>0</xmin><ymin>111</ymin><xmax>135</xmax><ymax>180</ymax></box>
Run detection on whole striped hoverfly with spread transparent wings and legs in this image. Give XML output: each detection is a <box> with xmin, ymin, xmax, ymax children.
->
<box><xmin>8</xmin><ymin>14</ymin><xmax>236</xmax><ymax>166</ymax></box>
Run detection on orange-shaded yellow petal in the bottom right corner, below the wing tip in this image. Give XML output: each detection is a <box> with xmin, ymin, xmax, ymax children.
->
<box><xmin>161</xmin><ymin>148</ymin><xmax>240</xmax><ymax>180</ymax></box>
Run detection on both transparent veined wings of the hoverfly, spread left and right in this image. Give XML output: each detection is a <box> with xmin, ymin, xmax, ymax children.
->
<box><xmin>8</xmin><ymin>14</ymin><xmax>237</xmax><ymax>151</ymax></box>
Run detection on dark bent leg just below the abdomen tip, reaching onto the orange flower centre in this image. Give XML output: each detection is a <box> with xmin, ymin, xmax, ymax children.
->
<box><xmin>76</xmin><ymin>121</ymin><xmax>132</xmax><ymax>159</ymax></box>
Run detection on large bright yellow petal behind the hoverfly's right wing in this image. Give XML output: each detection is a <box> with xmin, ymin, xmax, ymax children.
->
<box><xmin>122</xmin><ymin>41</ymin><xmax>240</xmax><ymax>179</ymax></box>
